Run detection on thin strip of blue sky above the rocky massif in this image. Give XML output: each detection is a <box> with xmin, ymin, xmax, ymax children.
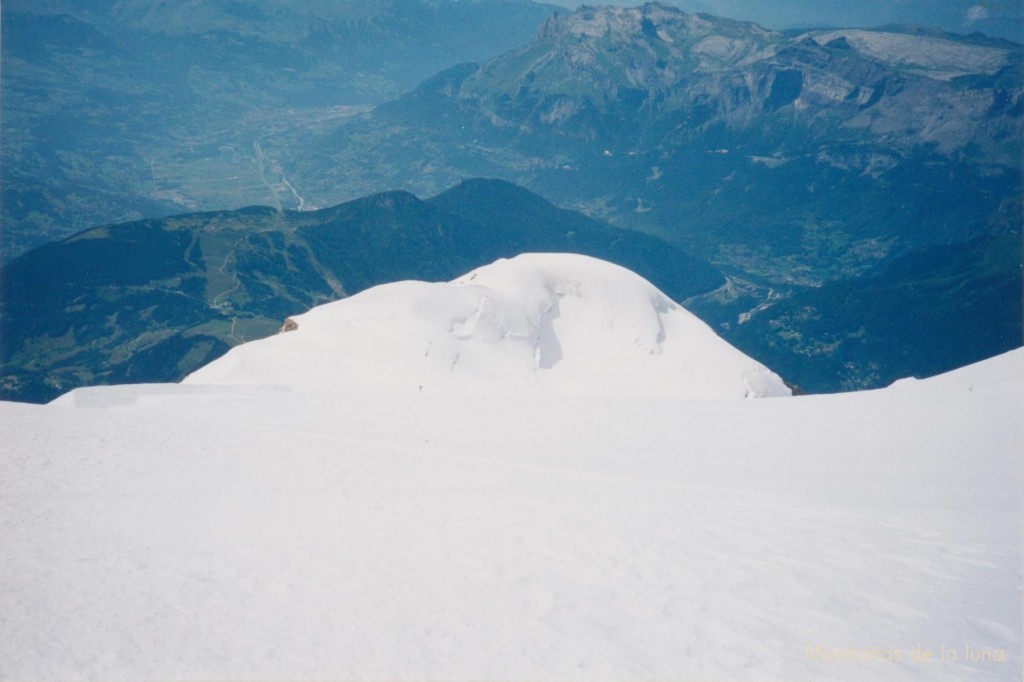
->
<box><xmin>551</xmin><ymin>0</ymin><xmax>1024</xmax><ymax>41</ymax></box>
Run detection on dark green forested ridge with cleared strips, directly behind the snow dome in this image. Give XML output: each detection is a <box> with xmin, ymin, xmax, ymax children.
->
<box><xmin>0</xmin><ymin>180</ymin><xmax>724</xmax><ymax>401</ymax></box>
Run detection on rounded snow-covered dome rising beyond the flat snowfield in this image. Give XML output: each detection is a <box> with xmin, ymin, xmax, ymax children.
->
<box><xmin>185</xmin><ymin>254</ymin><xmax>790</xmax><ymax>397</ymax></box>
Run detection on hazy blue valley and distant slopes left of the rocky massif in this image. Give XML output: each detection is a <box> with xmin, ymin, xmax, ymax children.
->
<box><xmin>0</xmin><ymin>0</ymin><xmax>561</xmax><ymax>260</ymax></box>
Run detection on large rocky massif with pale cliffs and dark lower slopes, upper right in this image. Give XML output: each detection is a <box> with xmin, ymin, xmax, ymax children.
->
<box><xmin>290</xmin><ymin>4</ymin><xmax>1024</xmax><ymax>285</ymax></box>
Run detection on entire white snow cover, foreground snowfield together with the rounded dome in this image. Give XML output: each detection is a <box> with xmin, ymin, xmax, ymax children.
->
<box><xmin>0</xmin><ymin>251</ymin><xmax>1024</xmax><ymax>682</ymax></box>
